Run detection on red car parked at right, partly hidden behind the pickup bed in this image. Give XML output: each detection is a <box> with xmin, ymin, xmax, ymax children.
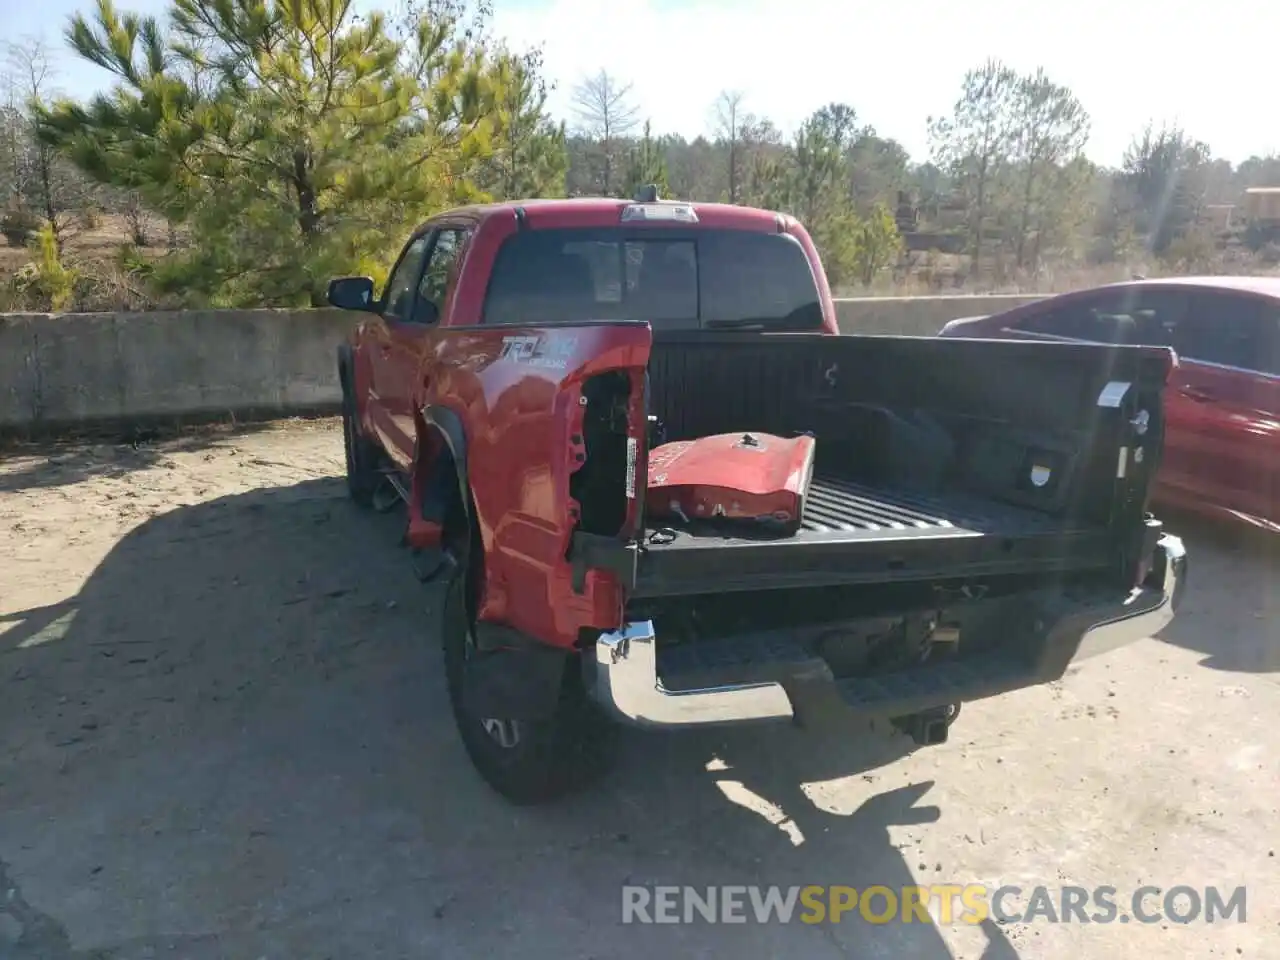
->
<box><xmin>940</xmin><ymin>276</ymin><xmax>1280</xmax><ymax>531</ymax></box>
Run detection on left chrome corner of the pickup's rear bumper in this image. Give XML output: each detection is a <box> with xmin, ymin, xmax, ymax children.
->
<box><xmin>593</xmin><ymin>620</ymin><xmax>792</xmax><ymax>727</ymax></box>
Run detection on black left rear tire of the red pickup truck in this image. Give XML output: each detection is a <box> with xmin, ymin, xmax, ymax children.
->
<box><xmin>440</xmin><ymin>535</ymin><xmax>617</xmax><ymax>806</ymax></box>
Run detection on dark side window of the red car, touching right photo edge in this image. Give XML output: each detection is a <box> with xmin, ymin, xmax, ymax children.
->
<box><xmin>1171</xmin><ymin>293</ymin><xmax>1280</xmax><ymax>374</ymax></box>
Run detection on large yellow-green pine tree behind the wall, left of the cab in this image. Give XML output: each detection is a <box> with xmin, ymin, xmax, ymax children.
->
<box><xmin>41</xmin><ymin>0</ymin><xmax>545</xmax><ymax>305</ymax></box>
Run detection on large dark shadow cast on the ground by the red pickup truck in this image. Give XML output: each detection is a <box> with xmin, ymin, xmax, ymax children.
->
<box><xmin>0</xmin><ymin>480</ymin><xmax>1016</xmax><ymax>960</ymax></box>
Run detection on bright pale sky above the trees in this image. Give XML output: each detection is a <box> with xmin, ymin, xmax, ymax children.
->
<box><xmin>0</xmin><ymin>0</ymin><xmax>1280</xmax><ymax>164</ymax></box>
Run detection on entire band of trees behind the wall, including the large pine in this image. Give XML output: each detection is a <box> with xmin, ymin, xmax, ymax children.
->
<box><xmin>0</xmin><ymin>0</ymin><xmax>1280</xmax><ymax>307</ymax></box>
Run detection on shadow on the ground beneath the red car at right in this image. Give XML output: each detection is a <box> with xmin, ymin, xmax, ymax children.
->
<box><xmin>1160</xmin><ymin>509</ymin><xmax>1280</xmax><ymax>673</ymax></box>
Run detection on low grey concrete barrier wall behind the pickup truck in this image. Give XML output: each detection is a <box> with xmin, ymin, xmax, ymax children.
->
<box><xmin>0</xmin><ymin>297</ymin><xmax>1034</xmax><ymax>430</ymax></box>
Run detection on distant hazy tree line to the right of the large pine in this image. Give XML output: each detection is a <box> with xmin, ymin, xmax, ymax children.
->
<box><xmin>567</xmin><ymin>60</ymin><xmax>1280</xmax><ymax>284</ymax></box>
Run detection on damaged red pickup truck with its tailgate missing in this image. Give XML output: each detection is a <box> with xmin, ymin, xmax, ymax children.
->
<box><xmin>329</xmin><ymin>196</ymin><xmax>1187</xmax><ymax>803</ymax></box>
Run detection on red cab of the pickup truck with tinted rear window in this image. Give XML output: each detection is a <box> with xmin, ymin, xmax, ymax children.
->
<box><xmin>330</xmin><ymin>198</ymin><xmax>838</xmax><ymax>470</ymax></box>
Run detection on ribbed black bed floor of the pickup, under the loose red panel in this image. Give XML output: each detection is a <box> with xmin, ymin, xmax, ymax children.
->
<box><xmin>635</xmin><ymin>476</ymin><xmax>1111</xmax><ymax>596</ymax></box>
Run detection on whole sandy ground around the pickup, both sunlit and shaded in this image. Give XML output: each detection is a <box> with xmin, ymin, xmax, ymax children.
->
<box><xmin>0</xmin><ymin>421</ymin><xmax>1280</xmax><ymax>960</ymax></box>
